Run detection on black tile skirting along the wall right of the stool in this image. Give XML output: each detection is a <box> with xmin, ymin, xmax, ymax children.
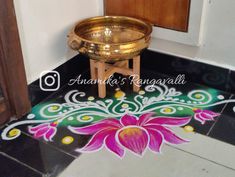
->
<box><xmin>141</xmin><ymin>50</ymin><xmax>232</xmax><ymax>93</ymax></box>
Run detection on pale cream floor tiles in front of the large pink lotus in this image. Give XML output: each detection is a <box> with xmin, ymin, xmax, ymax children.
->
<box><xmin>59</xmin><ymin>133</ymin><xmax>235</xmax><ymax>177</ymax></box>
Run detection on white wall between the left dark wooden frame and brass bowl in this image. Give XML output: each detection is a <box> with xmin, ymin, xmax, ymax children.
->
<box><xmin>14</xmin><ymin>0</ymin><xmax>102</xmax><ymax>83</ymax></box>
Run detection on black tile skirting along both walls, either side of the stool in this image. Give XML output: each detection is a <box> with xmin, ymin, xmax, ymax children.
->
<box><xmin>28</xmin><ymin>50</ymin><xmax>235</xmax><ymax>106</ymax></box>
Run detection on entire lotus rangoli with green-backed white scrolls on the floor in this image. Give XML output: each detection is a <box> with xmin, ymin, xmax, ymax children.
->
<box><xmin>1</xmin><ymin>85</ymin><xmax>235</xmax><ymax>158</ymax></box>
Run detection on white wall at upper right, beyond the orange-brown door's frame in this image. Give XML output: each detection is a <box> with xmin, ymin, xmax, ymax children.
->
<box><xmin>197</xmin><ymin>0</ymin><xmax>235</xmax><ymax>70</ymax></box>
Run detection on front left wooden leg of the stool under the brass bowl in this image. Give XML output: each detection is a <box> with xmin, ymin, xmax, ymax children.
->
<box><xmin>98</xmin><ymin>62</ymin><xmax>106</xmax><ymax>98</ymax></box>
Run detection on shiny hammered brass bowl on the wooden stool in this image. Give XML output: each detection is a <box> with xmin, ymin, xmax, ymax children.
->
<box><xmin>68</xmin><ymin>16</ymin><xmax>152</xmax><ymax>62</ymax></box>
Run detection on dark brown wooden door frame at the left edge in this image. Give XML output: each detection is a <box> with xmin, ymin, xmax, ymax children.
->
<box><xmin>0</xmin><ymin>0</ymin><xmax>31</xmax><ymax>123</ymax></box>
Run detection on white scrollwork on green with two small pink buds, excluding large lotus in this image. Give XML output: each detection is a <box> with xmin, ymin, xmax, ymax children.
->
<box><xmin>1</xmin><ymin>85</ymin><xmax>235</xmax><ymax>158</ymax></box>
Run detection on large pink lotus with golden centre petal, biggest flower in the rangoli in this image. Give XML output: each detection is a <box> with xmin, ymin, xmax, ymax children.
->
<box><xmin>69</xmin><ymin>113</ymin><xmax>190</xmax><ymax>157</ymax></box>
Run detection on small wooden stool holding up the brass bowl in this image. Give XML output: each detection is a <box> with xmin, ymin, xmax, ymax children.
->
<box><xmin>90</xmin><ymin>55</ymin><xmax>140</xmax><ymax>98</ymax></box>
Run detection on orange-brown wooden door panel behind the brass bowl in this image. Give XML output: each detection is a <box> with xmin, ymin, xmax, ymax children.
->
<box><xmin>104</xmin><ymin>0</ymin><xmax>190</xmax><ymax>32</ymax></box>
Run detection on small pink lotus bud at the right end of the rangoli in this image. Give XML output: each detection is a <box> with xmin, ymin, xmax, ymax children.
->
<box><xmin>194</xmin><ymin>109</ymin><xmax>220</xmax><ymax>124</ymax></box>
